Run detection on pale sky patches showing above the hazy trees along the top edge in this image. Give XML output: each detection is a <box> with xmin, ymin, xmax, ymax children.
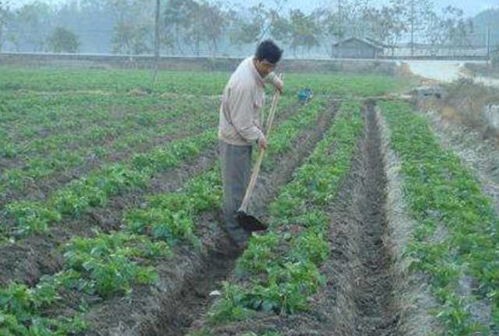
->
<box><xmin>10</xmin><ymin>0</ymin><xmax>499</xmax><ymax>16</ymax></box>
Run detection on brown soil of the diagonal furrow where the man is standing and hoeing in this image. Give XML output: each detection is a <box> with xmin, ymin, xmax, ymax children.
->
<box><xmin>83</xmin><ymin>102</ymin><xmax>335</xmax><ymax>336</ymax></box>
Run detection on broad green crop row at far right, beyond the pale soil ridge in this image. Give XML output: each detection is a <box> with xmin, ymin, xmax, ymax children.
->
<box><xmin>380</xmin><ymin>102</ymin><xmax>499</xmax><ymax>335</ymax></box>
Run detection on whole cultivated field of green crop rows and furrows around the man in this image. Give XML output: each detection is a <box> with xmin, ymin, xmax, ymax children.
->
<box><xmin>0</xmin><ymin>68</ymin><xmax>499</xmax><ymax>336</ymax></box>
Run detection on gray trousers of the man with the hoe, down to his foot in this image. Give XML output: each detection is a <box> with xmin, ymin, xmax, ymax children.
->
<box><xmin>219</xmin><ymin>141</ymin><xmax>252</xmax><ymax>244</ymax></box>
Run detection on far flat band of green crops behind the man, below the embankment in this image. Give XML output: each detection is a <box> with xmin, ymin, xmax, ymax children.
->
<box><xmin>0</xmin><ymin>68</ymin><xmax>401</xmax><ymax>96</ymax></box>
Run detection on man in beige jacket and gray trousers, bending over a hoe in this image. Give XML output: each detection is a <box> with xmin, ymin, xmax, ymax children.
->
<box><xmin>218</xmin><ymin>40</ymin><xmax>284</xmax><ymax>248</ymax></box>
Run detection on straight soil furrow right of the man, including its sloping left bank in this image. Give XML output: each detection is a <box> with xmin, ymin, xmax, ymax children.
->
<box><xmin>317</xmin><ymin>102</ymin><xmax>399</xmax><ymax>336</ymax></box>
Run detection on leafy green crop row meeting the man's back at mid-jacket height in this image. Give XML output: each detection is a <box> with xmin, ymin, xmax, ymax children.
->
<box><xmin>0</xmin><ymin>96</ymin><xmax>221</xmax><ymax>195</ymax></box>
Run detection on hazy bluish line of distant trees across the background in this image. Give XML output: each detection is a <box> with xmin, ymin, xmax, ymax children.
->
<box><xmin>0</xmin><ymin>0</ymin><xmax>499</xmax><ymax>56</ymax></box>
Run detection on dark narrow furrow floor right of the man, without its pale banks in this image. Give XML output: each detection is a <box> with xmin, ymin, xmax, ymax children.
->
<box><xmin>354</xmin><ymin>105</ymin><xmax>398</xmax><ymax>336</ymax></box>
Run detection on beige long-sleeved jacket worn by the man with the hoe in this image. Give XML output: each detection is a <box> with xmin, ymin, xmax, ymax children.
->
<box><xmin>218</xmin><ymin>57</ymin><xmax>280</xmax><ymax>146</ymax></box>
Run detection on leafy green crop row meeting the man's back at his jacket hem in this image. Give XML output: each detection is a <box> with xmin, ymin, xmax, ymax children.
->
<box><xmin>4</xmin><ymin>130</ymin><xmax>216</xmax><ymax>240</ymax></box>
